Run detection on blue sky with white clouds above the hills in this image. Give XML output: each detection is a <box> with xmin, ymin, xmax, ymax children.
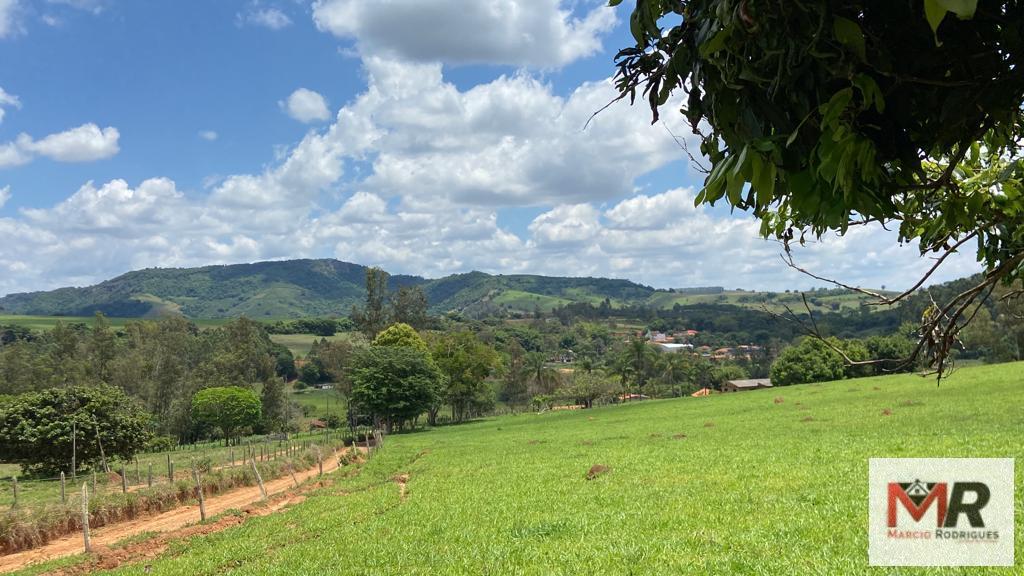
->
<box><xmin>0</xmin><ymin>0</ymin><xmax>974</xmax><ymax>293</ymax></box>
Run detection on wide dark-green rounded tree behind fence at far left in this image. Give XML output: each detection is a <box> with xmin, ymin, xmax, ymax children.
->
<box><xmin>0</xmin><ymin>385</ymin><xmax>153</xmax><ymax>474</ymax></box>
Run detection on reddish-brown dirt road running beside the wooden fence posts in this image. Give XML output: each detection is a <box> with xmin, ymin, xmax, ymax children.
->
<box><xmin>0</xmin><ymin>452</ymin><xmax>360</xmax><ymax>573</ymax></box>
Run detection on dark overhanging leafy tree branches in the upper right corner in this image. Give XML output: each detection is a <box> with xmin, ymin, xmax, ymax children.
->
<box><xmin>610</xmin><ymin>0</ymin><xmax>1024</xmax><ymax>371</ymax></box>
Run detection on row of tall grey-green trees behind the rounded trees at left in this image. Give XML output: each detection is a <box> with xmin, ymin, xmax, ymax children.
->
<box><xmin>0</xmin><ymin>314</ymin><xmax>295</xmax><ymax>441</ymax></box>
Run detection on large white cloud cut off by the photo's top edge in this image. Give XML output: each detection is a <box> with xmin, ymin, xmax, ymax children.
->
<box><xmin>313</xmin><ymin>0</ymin><xmax>615</xmax><ymax>69</ymax></box>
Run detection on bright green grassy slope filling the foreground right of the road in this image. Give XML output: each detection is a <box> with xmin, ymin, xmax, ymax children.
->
<box><xmin>75</xmin><ymin>364</ymin><xmax>1024</xmax><ymax>575</ymax></box>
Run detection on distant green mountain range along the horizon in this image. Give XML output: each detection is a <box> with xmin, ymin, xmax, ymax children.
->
<box><xmin>0</xmin><ymin>259</ymin><xmax>880</xmax><ymax>319</ymax></box>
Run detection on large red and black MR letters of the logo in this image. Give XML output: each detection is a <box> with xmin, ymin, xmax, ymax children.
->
<box><xmin>888</xmin><ymin>480</ymin><xmax>991</xmax><ymax>528</ymax></box>
